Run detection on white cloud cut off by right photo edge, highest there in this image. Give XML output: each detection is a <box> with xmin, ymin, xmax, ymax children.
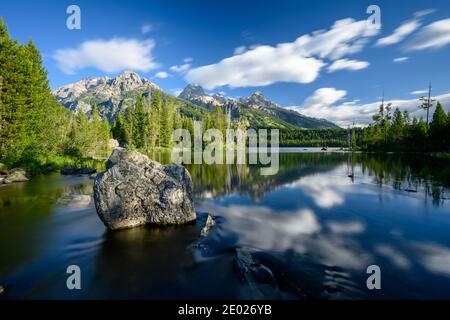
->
<box><xmin>406</xmin><ymin>18</ymin><xmax>450</xmax><ymax>50</ymax></box>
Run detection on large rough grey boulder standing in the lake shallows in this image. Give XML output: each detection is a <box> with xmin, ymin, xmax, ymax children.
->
<box><xmin>94</xmin><ymin>149</ymin><xmax>196</xmax><ymax>230</ymax></box>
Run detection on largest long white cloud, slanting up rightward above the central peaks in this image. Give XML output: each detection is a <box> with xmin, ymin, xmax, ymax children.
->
<box><xmin>186</xmin><ymin>18</ymin><xmax>378</xmax><ymax>90</ymax></box>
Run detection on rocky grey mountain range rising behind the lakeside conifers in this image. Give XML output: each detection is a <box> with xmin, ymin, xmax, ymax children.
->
<box><xmin>53</xmin><ymin>71</ymin><xmax>338</xmax><ymax>129</ymax></box>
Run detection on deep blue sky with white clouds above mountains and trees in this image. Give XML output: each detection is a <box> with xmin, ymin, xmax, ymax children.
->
<box><xmin>0</xmin><ymin>0</ymin><xmax>450</xmax><ymax>125</ymax></box>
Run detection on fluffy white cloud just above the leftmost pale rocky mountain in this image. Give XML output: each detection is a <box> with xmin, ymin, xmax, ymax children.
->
<box><xmin>53</xmin><ymin>38</ymin><xmax>157</xmax><ymax>74</ymax></box>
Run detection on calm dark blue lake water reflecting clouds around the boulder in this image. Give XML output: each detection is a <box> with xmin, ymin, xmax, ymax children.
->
<box><xmin>0</xmin><ymin>149</ymin><xmax>450</xmax><ymax>299</ymax></box>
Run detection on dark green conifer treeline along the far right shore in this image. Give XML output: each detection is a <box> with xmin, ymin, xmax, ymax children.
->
<box><xmin>280</xmin><ymin>102</ymin><xmax>450</xmax><ymax>152</ymax></box>
